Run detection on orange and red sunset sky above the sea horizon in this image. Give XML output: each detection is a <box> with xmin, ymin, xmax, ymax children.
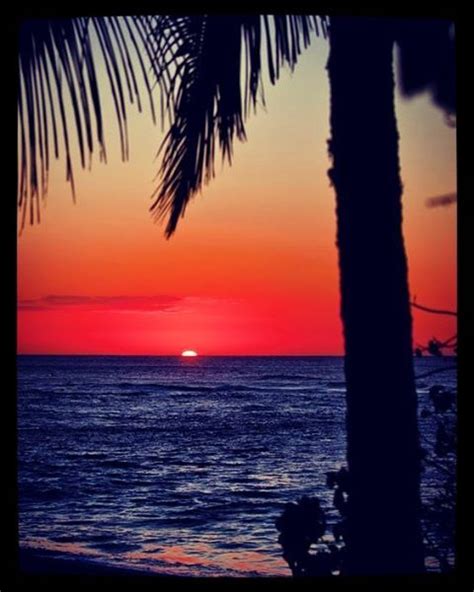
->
<box><xmin>18</xmin><ymin>27</ymin><xmax>456</xmax><ymax>355</ymax></box>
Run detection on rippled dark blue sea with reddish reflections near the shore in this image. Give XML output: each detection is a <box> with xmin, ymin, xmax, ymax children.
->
<box><xmin>18</xmin><ymin>356</ymin><xmax>455</xmax><ymax>576</ymax></box>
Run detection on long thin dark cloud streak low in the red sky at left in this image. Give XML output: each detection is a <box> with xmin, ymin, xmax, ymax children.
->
<box><xmin>18</xmin><ymin>294</ymin><xmax>184</xmax><ymax>312</ymax></box>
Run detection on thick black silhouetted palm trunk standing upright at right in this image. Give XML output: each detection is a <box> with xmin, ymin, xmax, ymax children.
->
<box><xmin>328</xmin><ymin>17</ymin><xmax>423</xmax><ymax>574</ymax></box>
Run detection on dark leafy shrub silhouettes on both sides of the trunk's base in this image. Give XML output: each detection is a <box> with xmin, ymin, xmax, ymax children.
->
<box><xmin>276</xmin><ymin>385</ymin><xmax>457</xmax><ymax>577</ymax></box>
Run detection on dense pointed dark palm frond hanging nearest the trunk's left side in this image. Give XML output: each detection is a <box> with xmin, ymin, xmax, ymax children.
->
<box><xmin>149</xmin><ymin>15</ymin><xmax>327</xmax><ymax>238</ymax></box>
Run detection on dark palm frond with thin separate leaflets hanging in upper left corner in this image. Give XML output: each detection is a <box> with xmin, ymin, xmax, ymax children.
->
<box><xmin>18</xmin><ymin>17</ymin><xmax>156</xmax><ymax>228</ymax></box>
